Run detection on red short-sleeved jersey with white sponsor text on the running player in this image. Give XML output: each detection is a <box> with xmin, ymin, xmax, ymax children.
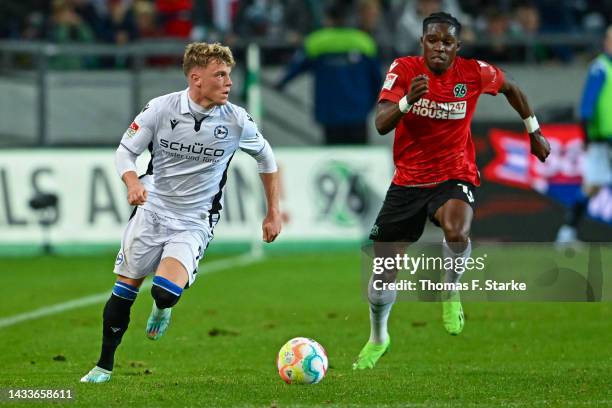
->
<box><xmin>379</xmin><ymin>57</ymin><xmax>504</xmax><ymax>186</ymax></box>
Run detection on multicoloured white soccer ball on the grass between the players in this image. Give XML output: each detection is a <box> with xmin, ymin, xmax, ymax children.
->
<box><xmin>276</xmin><ymin>337</ymin><xmax>327</xmax><ymax>384</ymax></box>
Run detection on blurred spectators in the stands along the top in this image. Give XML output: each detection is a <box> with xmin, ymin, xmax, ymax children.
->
<box><xmin>0</xmin><ymin>0</ymin><xmax>612</xmax><ymax>62</ymax></box>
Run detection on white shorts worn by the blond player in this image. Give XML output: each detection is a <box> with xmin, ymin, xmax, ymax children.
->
<box><xmin>115</xmin><ymin>207</ymin><xmax>213</xmax><ymax>286</ymax></box>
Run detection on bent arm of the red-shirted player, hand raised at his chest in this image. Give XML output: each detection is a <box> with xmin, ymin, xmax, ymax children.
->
<box><xmin>375</xmin><ymin>75</ymin><xmax>429</xmax><ymax>135</ymax></box>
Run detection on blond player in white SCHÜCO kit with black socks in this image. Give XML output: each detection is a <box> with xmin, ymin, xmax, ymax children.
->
<box><xmin>81</xmin><ymin>43</ymin><xmax>281</xmax><ymax>383</ymax></box>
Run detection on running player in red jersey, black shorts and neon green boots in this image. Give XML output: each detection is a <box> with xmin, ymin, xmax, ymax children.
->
<box><xmin>353</xmin><ymin>13</ymin><xmax>550</xmax><ymax>369</ymax></box>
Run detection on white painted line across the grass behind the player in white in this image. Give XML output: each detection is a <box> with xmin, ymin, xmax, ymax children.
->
<box><xmin>0</xmin><ymin>254</ymin><xmax>261</xmax><ymax>329</ymax></box>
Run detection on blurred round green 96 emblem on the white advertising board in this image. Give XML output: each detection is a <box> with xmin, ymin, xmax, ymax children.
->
<box><xmin>315</xmin><ymin>161</ymin><xmax>371</xmax><ymax>226</ymax></box>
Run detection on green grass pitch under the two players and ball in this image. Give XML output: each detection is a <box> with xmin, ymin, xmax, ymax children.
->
<box><xmin>0</xmin><ymin>251</ymin><xmax>612</xmax><ymax>407</ymax></box>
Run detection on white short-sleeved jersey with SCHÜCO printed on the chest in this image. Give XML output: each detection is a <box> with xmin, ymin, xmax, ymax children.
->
<box><xmin>121</xmin><ymin>90</ymin><xmax>265</xmax><ymax>226</ymax></box>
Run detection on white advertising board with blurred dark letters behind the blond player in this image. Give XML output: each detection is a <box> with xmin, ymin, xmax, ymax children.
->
<box><xmin>0</xmin><ymin>147</ymin><xmax>393</xmax><ymax>245</ymax></box>
